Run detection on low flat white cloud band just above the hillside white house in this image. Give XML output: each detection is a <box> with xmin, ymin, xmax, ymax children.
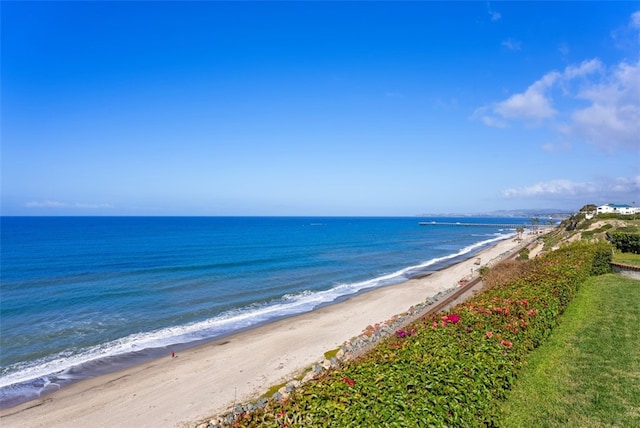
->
<box><xmin>502</xmin><ymin>175</ymin><xmax>640</xmax><ymax>203</ymax></box>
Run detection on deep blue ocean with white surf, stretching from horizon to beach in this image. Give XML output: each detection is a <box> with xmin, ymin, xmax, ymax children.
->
<box><xmin>0</xmin><ymin>217</ymin><xmax>529</xmax><ymax>408</ymax></box>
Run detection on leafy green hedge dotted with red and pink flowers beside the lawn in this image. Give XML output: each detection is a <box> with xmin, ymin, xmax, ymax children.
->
<box><xmin>229</xmin><ymin>243</ymin><xmax>611</xmax><ymax>427</ymax></box>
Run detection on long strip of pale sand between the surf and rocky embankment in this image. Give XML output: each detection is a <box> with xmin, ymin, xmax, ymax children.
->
<box><xmin>0</xmin><ymin>235</ymin><xmax>536</xmax><ymax>428</ymax></box>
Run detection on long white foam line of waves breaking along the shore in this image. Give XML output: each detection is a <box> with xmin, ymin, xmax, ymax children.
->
<box><xmin>0</xmin><ymin>234</ymin><xmax>513</xmax><ymax>388</ymax></box>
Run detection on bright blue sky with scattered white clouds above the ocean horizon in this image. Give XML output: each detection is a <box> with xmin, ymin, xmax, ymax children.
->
<box><xmin>1</xmin><ymin>1</ymin><xmax>640</xmax><ymax>215</ymax></box>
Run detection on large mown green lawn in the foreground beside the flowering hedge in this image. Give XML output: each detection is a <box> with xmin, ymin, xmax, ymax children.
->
<box><xmin>500</xmin><ymin>274</ymin><xmax>640</xmax><ymax>427</ymax></box>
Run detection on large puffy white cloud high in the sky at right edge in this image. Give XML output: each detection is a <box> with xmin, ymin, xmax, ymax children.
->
<box><xmin>474</xmin><ymin>59</ymin><xmax>640</xmax><ymax>151</ymax></box>
